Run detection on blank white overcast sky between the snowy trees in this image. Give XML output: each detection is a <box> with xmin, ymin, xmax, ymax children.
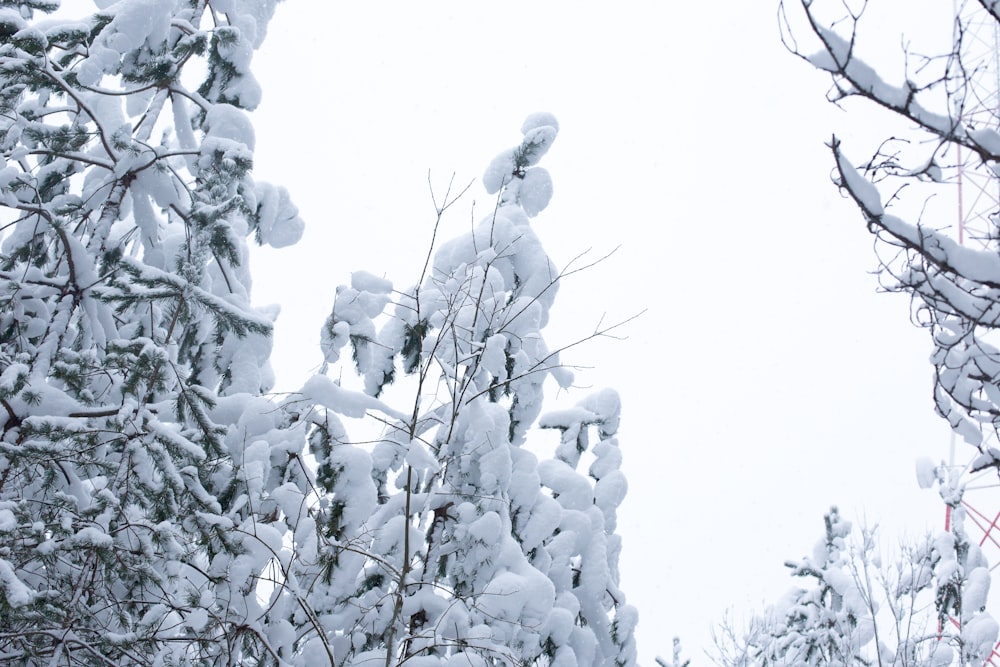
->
<box><xmin>244</xmin><ymin>0</ymin><xmax>976</xmax><ymax>665</ymax></box>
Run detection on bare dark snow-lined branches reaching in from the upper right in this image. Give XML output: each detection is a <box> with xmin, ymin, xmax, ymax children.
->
<box><xmin>779</xmin><ymin>0</ymin><xmax>1000</xmax><ymax>470</ymax></box>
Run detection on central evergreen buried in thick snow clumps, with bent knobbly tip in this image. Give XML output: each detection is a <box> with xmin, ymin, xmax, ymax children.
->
<box><xmin>278</xmin><ymin>114</ymin><xmax>636</xmax><ymax>665</ymax></box>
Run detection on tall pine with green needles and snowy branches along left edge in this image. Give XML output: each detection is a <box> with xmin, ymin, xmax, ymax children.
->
<box><xmin>0</xmin><ymin>0</ymin><xmax>301</xmax><ymax>665</ymax></box>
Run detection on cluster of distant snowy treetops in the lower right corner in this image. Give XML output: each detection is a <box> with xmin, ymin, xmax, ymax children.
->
<box><xmin>714</xmin><ymin>500</ymin><xmax>997</xmax><ymax>667</ymax></box>
